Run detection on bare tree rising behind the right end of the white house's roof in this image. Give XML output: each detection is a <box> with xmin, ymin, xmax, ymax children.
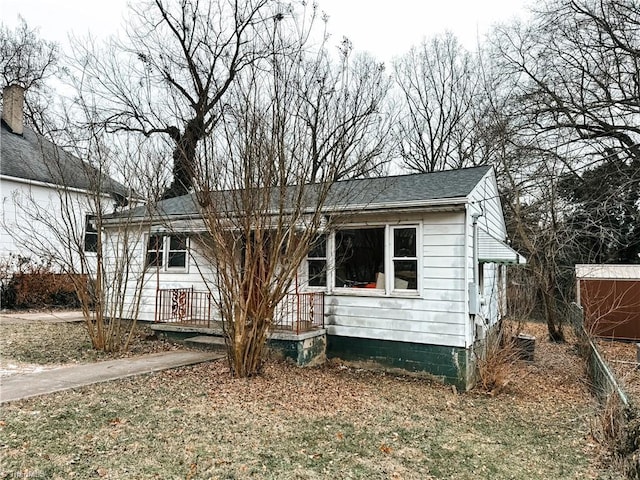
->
<box><xmin>395</xmin><ymin>33</ymin><xmax>477</xmax><ymax>172</ymax></box>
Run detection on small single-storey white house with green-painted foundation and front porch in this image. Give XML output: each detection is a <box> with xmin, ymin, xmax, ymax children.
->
<box><xmin>106</xmin><ymin>166</ymin><xmax>525</xmax><ymax>388</ymax></box>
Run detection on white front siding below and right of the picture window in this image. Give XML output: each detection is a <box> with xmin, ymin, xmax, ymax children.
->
<box><xmin>325</xmin><ymin>210</ymin><xmax>468</xmax><ymax>347</ymax></box>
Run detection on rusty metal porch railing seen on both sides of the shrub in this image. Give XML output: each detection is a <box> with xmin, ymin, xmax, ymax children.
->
<box><xmin>155</xmin><ymin>288</ymin><xmax>324</xmax><ymax>334</ymax></box>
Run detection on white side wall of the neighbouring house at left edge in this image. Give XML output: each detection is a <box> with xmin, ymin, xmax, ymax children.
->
<box><xmin>0</xmin><ymin>177</ymin><xmax>102</xmax><ymax>274</ymax></box>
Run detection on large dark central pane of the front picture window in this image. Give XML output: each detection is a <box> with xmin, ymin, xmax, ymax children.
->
<box><xmin>335</xmin><ymin>227</ymin><xmax>385</xmax><ymax>289</ymax></box>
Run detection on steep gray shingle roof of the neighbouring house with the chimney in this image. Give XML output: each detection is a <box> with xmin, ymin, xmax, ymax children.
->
<box><xmin>0</xmin><ymin>121</ymin><xmax>127</xmax><ymax>196</ymax></box>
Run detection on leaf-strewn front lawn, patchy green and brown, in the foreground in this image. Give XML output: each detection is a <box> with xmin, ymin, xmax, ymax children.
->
<box><xmin>0</xmin><ymin>325</ymin><xmax>620</xmax><ymax>480</ymax></box>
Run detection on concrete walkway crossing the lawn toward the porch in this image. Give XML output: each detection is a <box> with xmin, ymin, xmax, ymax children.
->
<box><xmin>0</xmin><ymin>351</ymin><xmax>224</xmax><ymax>403</ymax></box>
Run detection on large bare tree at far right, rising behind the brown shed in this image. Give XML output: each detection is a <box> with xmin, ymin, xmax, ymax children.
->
<box><xmin>485</xmin><ymin>1</ymin><xmax>640</xmax><ymax>340</ymax></box>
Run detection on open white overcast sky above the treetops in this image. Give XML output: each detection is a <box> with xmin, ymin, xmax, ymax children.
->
<box><xmin>0</xmin><ymin>0</ymin><xmax>529</xmax><ymax>62</ymax></box>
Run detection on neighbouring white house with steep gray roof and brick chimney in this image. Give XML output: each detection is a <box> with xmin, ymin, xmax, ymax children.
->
<box><xmin>0</xmin><ymin>85</ymin><xmax>126</xmax><ymax>273</ymax></box>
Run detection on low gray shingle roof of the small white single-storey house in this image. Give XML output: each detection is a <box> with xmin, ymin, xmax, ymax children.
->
<box><xmin>122</xmin><ymin>166</ymin><xmax>492</xmax><ymax>218</ymax></box>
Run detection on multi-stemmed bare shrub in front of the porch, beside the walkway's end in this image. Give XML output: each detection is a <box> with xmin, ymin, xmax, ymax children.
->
<box><xmin>188</xmin><ymin>12</ymin><xmax>378</xmax><ymax>376</ymax></box>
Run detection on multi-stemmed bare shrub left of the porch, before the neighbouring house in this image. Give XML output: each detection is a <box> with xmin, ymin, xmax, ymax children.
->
<box><xmin>3</xmin><ymin>86</ymin><xmax>152</xmax><ymax>352</ymax></box>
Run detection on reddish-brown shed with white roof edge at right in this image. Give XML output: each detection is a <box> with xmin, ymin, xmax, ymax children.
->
<box><xmin>576</xmin><ymin>265</ymin><xmax>640</xmax><ymax>341</ymax></box>
